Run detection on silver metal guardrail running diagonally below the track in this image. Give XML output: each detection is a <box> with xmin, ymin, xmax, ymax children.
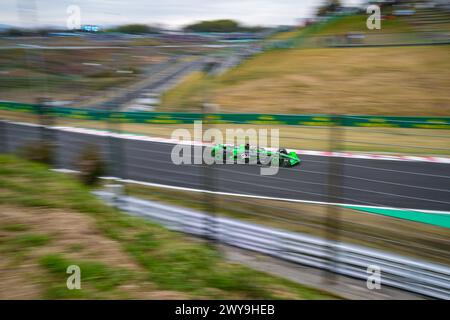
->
<box><xmin>95</xmin><ymin>191</ymin><xmax>450</xmax><ymax>300</ymax></box>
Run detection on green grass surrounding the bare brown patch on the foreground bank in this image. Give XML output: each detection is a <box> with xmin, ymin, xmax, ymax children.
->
<box><xmin>0</xmin><ymin>155</ymin><xmax>336</xmax><ymax>299</ymax></box>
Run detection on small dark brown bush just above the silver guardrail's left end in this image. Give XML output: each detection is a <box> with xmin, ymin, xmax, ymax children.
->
<box><xmin>77</xmin><ymin>144</ymin><xmax>106</xmax><ymax>186</ymax></box>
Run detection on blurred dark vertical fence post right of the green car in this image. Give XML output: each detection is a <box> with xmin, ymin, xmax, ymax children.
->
<box><xmin>324</xmin><ymin>115</ymin><xmax>345</xmax><ymax>284</ymax></box>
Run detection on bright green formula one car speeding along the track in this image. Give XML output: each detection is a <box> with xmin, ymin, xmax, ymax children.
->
<box><xmin>211</xmin><ymin>144</ymin><xmax>301</xmax><ymax>167</ymax></box>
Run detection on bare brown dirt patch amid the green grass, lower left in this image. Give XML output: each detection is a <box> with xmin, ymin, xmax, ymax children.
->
<box><xmin>0</xmin><ymin>206</ymin><xmax>184</xmax><ymax>299</ymax></box>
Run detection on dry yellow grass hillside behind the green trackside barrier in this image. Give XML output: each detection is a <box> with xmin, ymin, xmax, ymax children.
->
<box><xmin>163</xmin><ymin>46</ymin><xmax>450</xmax><ymax>116</ymax></box>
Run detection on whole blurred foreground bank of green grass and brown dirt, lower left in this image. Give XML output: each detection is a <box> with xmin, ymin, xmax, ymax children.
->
<box><xmin>0</xmin><ymin>155</ymin><xmax>336</xmax><ymax>299</ymax></box>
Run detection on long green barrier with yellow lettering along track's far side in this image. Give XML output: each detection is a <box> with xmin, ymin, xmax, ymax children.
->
<box><xmin>0</xmin><ymin>101</ymin><xmax>450</xmax><ymax>129</ymax></box>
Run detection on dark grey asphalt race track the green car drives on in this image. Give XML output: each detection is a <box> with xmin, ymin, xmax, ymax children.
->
<box><xmin>1</xmin><ymin>123</ymin><xmax>450</xmax><ymax>211</ymax></box>
